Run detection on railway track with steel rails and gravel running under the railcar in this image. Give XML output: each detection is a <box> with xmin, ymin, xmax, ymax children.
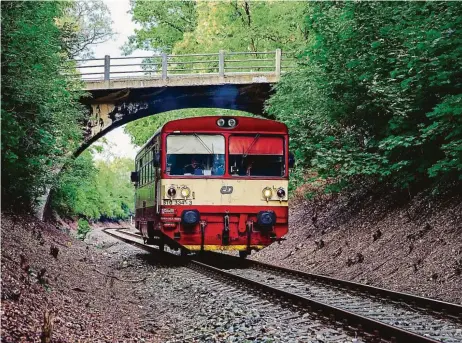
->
<box><xmin>106</xmin><ymin>229</ymin><xmax>462</xmax><ymax>343</ymax></box>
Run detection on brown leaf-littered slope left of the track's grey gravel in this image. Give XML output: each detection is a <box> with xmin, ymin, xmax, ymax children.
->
<box><xmin>1</xmin><ymin>214</ymin><xmax>162</xmax><ymax>342</ymax></box>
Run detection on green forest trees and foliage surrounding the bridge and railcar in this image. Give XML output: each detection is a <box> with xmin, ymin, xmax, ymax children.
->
<box><xmin>1</xmin><ymin>0</ymin><xmax>462</xmax><ymax>226</ymax></box>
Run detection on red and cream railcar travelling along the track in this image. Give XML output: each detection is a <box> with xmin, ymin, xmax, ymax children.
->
<box><xmin>132</xmin><ymin>116</ymin><xmax>289</xmax><ymax>256</ymax></box>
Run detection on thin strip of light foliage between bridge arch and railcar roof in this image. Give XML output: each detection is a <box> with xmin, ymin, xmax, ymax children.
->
<box><xmin>124</xmin><ymin>108</ymin><xmax>252</xmax><ymax>146</ymax></box>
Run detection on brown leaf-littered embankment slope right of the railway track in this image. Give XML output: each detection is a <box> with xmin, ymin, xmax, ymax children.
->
<box><xmin>252</xmin><ymin>190</ymin><xmax>462</xmax><ymax>304</ymax></box>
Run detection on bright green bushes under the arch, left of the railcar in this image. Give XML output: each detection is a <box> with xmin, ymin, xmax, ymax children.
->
<box><xmin>52</xmin><ymin>151</ymin><xmax>135</xmax><ymax>220</ymax></box>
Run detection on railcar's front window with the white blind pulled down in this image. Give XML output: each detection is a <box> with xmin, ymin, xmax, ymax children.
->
<box><xmin>166</xmin><ymin>134</ymin><xmax>225</xmax><ymax>176</ymax></box>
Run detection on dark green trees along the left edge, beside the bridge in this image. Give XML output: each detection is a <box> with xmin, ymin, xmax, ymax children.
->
<box><xmin>1</xmin><ymin>1</ymin><xmax>83</xmax><ymax>210</ymax></box>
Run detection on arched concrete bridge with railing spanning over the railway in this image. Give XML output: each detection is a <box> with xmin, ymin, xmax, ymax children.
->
<box><xmin>75</xmin><ymin>49</ymin><xmax>296</xmax><ymax>156</ymax></box>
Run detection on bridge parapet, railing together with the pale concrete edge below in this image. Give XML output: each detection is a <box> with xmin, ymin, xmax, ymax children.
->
<box><xmin>71</xmin><ymin>49</ymin><xmax>295</xmax><ymax>90</ymax></box>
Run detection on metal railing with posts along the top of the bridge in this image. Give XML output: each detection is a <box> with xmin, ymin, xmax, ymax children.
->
<box><xmin>69</xmin><ymin>49</ymin><xmax>296</xmax><ymax>81</ymax></box>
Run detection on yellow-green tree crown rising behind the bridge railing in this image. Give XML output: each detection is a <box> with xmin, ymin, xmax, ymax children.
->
<box><xmin>173</xmin><ymin>1</ymin><xmax>308</xmax><ymax>54</ymax></box>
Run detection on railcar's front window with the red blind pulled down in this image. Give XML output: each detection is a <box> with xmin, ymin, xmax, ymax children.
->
<box><xmin>229</xmin><ymin>134</ymin><xmax>285</xmax><ymax>177</ymax></box>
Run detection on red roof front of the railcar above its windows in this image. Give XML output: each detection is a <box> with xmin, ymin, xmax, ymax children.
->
<box><xmin>136</xmin><ymin>116</ymin><xmax>288</xmax><ymax>157</ymax></box>
